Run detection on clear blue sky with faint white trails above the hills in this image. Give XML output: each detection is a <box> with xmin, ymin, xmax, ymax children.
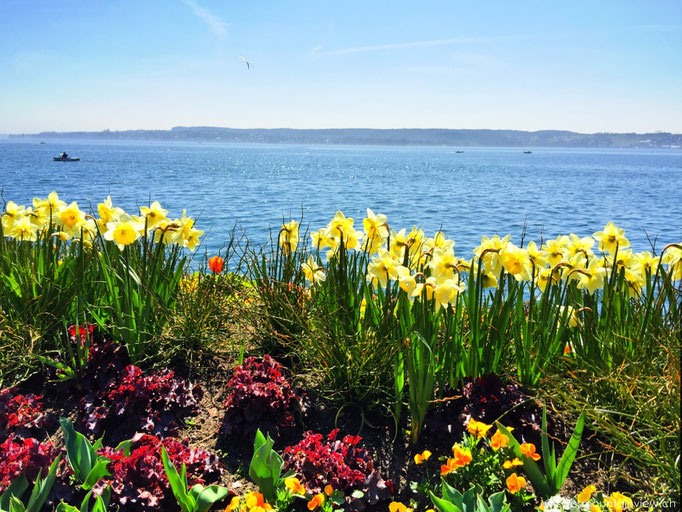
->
<box><xmin>0</xmin><ymin>0</ymin><xmax>682</xmax><ymax>133</ymax></box>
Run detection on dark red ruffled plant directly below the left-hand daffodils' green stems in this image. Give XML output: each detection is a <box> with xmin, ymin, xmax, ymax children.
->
<box><xmin>81</xmin><ymin>365</ymin><xmax>203</xmax><ymax>440</ymax></box>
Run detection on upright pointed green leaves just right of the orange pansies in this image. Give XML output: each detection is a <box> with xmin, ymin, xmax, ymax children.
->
<box><xmin>497</xmin><ymin>408</ymin><xmax>585</xmax><ymax>499</ymax></box>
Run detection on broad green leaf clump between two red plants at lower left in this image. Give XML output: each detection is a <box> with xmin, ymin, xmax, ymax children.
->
<box><xmin>59</xmin><ymin>418</ymin><xmax>111</xmax><ymax>491</ymax></box>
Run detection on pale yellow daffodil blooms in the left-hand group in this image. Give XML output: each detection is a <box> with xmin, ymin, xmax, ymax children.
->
<box><xmin>2</xmin><ymin>192</ymin><xmax>204</xmax><ymax>250</ymax></box>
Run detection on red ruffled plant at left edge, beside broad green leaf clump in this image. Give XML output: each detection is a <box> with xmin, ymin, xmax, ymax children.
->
<box><xmin>0</xmin><ymin>435</ymin><xmax>57</xmax><ymax>494</ymax></box>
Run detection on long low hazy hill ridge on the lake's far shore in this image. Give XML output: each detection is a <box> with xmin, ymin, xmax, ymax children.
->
<box><xmin>10</xmin><ymin>126</ymin><xmax>682</xmax><ymax>148</ymax></box>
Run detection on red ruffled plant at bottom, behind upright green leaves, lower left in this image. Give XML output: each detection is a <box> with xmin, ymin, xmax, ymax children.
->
<box><xmin>95</xmin><ymin>434</ymin><xmax>224</xmax><ymax>512</ymax></box>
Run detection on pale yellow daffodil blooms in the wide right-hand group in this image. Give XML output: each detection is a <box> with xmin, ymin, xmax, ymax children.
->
<box><xmin>294</xmin><ymin>208</ymin><xmax>682</xmax><ymax>302</ymax></box>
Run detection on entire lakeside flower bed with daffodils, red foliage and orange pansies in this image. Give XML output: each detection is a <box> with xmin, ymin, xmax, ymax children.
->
<box><xmin>0</xmin><ymin>193</ymin><xmax>682</xmax><ymax>512</ymax></box>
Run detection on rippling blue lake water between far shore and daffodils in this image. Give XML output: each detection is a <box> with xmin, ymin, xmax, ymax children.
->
<box><xmin>0</xmin><ymin>140</ymin><xmax>682</xmax><ymax>257</ymax></box>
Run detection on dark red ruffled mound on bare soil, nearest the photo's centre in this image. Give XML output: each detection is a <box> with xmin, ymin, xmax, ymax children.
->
<box><xmin>221</xmin><ymin>355</ymin><xmax>306</xmax><ymax>438</ymax></box>
